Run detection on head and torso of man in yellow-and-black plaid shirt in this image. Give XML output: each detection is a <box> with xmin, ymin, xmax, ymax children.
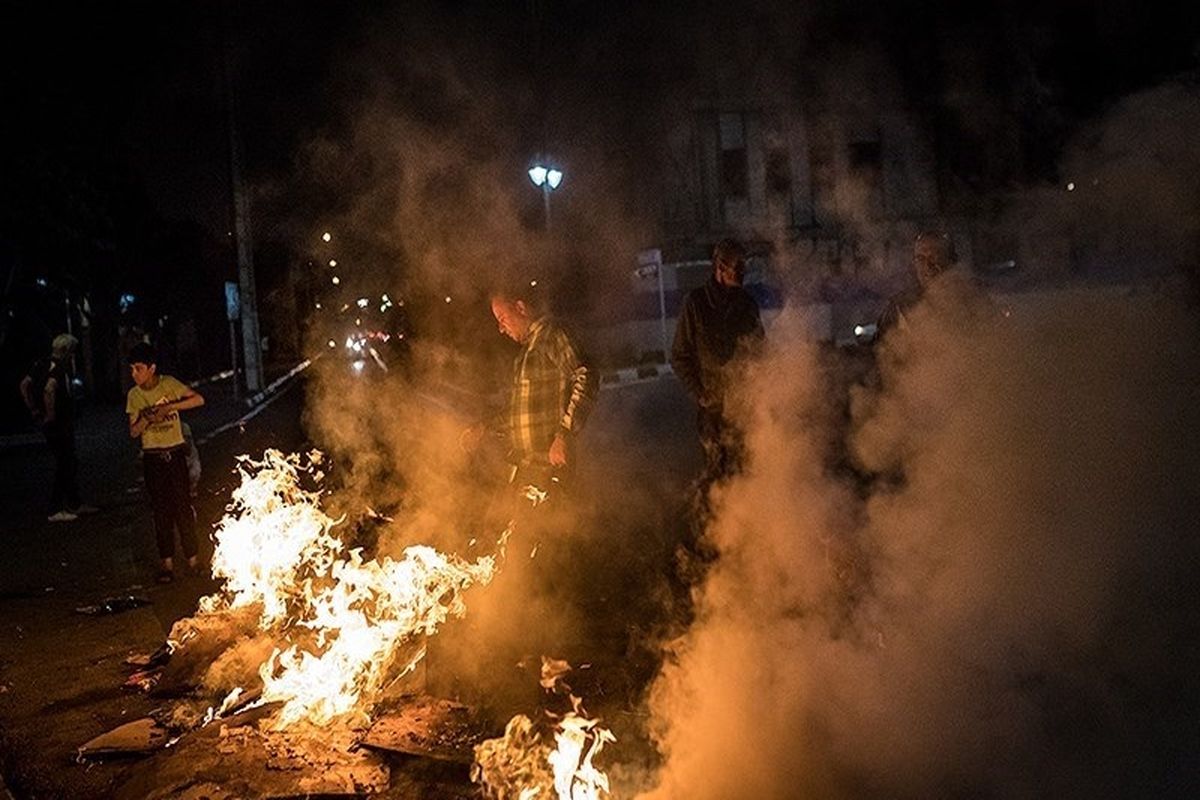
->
<box><xmin>492</xmin><ymin>287</ymin><xmax>599</xmax><ymax>473</ymax></box>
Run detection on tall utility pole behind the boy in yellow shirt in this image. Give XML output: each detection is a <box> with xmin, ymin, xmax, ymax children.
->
<box><xmin>224</xmin><ymin>5</ymin><xmax>263</xmax><ymax>395</ymax></box>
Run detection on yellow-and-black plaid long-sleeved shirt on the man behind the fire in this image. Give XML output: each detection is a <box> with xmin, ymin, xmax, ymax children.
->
<box><xmin>506</xmin><ymin>317</ymin><xmax>599</xmax><ymax>464</ymax></box>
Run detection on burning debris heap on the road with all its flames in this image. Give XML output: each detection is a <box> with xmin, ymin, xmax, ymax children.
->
<box><xmin>79</xmin><ymin>450</ymin><xmax>614</xmax><ymax>800</ymax></box>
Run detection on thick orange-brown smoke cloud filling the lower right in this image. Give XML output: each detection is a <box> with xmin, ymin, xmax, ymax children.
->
<box><xmin>649</xmin><ymin>276</ymin><xmax>1200</xmax><ymax>798</ymax></box>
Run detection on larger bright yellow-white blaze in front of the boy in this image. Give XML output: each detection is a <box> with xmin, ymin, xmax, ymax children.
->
<box><xmin>200</xmin><ymin>450</ymin><xmax>496</xmax><ymax>728</ymax></box>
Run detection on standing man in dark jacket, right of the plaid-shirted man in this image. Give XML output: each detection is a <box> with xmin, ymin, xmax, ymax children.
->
<box><xmin>671</xmin><ymin>239</ymin><xmax>763</xmax><ymax>489</ymax></box>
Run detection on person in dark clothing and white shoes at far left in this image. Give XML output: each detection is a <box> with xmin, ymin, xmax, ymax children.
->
<box><xmin>20</xmin><ymin>333</ymin><xmax>95</xmax><ymax>522</ymax></box>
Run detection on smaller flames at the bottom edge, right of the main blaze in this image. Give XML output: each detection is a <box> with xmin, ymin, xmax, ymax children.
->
<box><xmin>472</xmin><ymin>656</ymin><xmax>617</xmax><ymax>800</ymax></box>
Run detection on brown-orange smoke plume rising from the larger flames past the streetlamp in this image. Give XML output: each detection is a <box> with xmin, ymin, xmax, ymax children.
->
<box><xmin>250</xmin><ymin>6</ymin><xmax>710</xmax><ymax>712</ymax></box>
